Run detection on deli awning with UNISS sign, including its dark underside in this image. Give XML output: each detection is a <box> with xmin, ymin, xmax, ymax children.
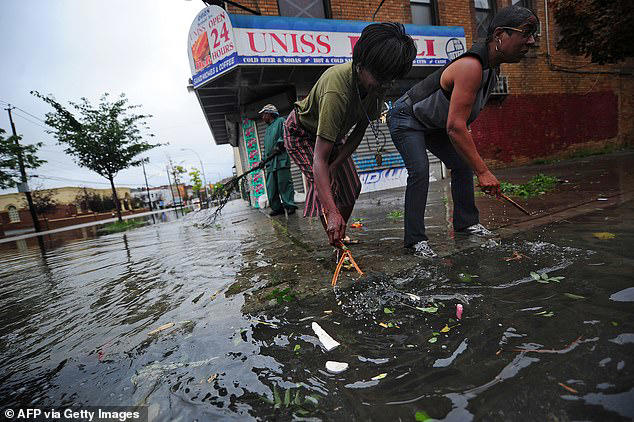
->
<box><xmin>188</xmin><ymin>6</ymin><xmax>466</xmax><ymax>146</ymax></box>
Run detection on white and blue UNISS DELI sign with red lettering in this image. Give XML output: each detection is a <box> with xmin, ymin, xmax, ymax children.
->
<box><xmin>189</xmin><ymin>6</ymin><xmax>465</xmax><ymax>87</ymax></box>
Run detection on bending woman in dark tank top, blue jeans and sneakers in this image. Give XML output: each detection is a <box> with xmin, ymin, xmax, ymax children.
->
<box><xmin>389</xmin><ymin>6</ymin><xmax>539</xmax><ymax>257</ymax></box>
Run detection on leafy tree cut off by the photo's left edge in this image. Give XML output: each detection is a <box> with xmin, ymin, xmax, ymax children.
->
<box><xmin>0</xmin><ymin>129</ymin><xmax>46</xmax><ymax>189</ymax></box>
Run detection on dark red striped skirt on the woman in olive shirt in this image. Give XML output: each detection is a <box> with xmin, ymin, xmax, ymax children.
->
<box><xmin>284</xmin><ymin>110</ymin><xmax>361</xmax><ymax>217</ymax></box>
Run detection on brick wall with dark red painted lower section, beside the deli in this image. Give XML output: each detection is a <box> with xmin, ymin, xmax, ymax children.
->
<box><xmin>220</xmin><ymin>0</ymin><xmax>634</xmax><ymax>162</ymax></box>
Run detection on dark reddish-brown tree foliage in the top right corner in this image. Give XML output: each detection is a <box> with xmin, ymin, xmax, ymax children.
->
<box><xmin>550</xmin><ymin>0</ymin><xmax>634</xmax><ymax>64</ymax></box>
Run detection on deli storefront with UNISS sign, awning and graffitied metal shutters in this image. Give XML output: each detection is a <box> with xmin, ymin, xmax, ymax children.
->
<box><xmin>188</xmin><ymin>6</ymin><xmax>466</xmax><ymax>208</ymax></box>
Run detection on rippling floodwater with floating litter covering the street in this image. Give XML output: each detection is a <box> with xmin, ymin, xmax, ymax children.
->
<box><xmin>0</xmin><ymin>202</ymin><xmax>634</xmax><ymax>421</ymax></box>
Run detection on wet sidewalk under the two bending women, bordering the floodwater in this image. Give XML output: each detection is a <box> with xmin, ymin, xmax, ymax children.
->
<box><xmin>228</xmin><ymin>151</ymin><xmax>634</xmax><ymax>312</ymax></box>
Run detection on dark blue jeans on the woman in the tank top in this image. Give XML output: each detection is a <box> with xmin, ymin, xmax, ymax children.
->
<box><xmin>388</xmin><ymin>100</ymin><xmax>480</xmax><ymax>247</ymax></box>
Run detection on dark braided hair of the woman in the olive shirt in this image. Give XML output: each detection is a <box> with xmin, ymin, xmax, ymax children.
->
<box><xmin>352</xmin><ymin>22</ymin><xmax>416</xmax><ymax>81</ymax></box>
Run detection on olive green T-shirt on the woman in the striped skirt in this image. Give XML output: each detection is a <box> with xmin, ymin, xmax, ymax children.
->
<box><xmin>295</xmin><ymin>62</ymin><xmax>383</xmax><ymax>142</ymax></box>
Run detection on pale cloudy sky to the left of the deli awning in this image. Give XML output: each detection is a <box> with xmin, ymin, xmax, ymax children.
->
<box><xmin>0</xmin><ymin>0</ymin><xmax>233</xmax><ymax>193</ymax></box>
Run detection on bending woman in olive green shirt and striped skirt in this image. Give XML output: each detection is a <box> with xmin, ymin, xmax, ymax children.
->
<box><xmin>284</xmin><ymin>23</ymin><xmax>416</xmax><ymax>246</ymax></box>
